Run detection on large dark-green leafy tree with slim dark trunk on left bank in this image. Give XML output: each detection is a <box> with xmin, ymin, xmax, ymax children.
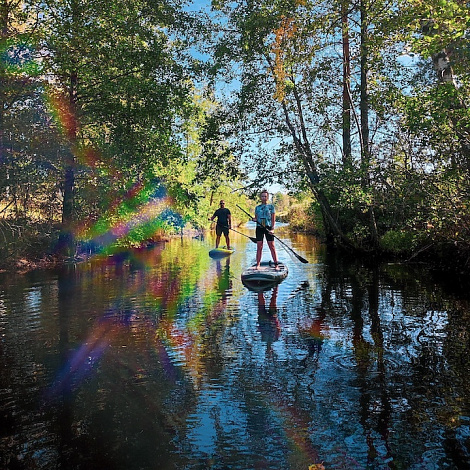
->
<box><xmin>41</xmin><ymin>0</ymin><xmax>207</xmax><ymax>254</ymax></box>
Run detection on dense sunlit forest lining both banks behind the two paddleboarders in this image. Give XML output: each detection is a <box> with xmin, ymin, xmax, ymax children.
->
<box><xmin>0</xmin><ymin>0</ymin><xmax>470</xmax><ymax>268</ymax></box>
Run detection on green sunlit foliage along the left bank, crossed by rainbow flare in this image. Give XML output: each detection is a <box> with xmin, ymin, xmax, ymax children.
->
<box><xmin>0</xmin><ymin>0</ymin><xmax>250</xmax><ymax>260</ymax></box>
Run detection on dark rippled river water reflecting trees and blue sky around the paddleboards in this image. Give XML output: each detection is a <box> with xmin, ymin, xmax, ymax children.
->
<box><xmin>0</xmin><ymin>228</ymin><xmax>470</xmax><ymax>470</ymax></box>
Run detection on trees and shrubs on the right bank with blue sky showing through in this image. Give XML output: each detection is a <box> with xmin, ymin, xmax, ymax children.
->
<box><xmin>209</xmin><ymin>0</ymin><xmax>470</xmax><ymax>260</ymax></box>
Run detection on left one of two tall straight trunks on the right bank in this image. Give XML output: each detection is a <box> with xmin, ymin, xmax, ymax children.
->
<box><xmin>341</xmin><ymin>0</ymin><xmax>352</xmax><ymax>168</ymax></box>
